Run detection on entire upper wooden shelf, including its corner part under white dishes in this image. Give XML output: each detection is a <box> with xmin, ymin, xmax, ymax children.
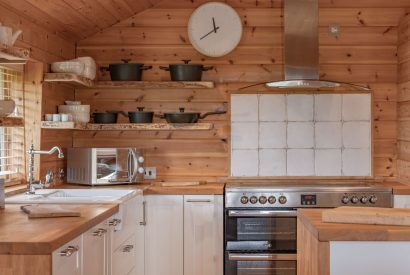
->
<box><xmin>44</xmin><ymin>73</ymin><xmax>215</xmax><ymax>89</ymax></box>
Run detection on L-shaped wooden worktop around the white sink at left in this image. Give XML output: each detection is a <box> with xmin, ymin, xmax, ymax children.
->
<box><xmin>0</xmin><ymin>204</ymin><xmax>118</xmax><ymax>255</ymax></box>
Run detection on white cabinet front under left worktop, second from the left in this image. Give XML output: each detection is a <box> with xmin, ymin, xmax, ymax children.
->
<box><xmin>83</xmin><ymin>222</ymin><xmax>110</xmax><ymax>275</ymax></box>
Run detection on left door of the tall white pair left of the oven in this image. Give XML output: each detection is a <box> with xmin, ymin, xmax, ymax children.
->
<box><xmin>145</xmin><ymin>195</ymin><xmax>183</xmax><ymax>275</ymax></box>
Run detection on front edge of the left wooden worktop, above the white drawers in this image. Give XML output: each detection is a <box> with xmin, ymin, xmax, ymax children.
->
<box><xmin>0</xmin><ymin>204</ymin><xmax>119</xmax><ymax>255</ymax></box>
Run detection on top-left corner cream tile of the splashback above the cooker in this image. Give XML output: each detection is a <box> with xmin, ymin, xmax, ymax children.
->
<box><xmin>231</xmin><ymin>94</ymin><xmax>258</xmax><ymax>122</ymax></box>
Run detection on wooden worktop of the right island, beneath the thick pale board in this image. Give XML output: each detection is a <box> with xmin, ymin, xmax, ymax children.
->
<box><xmin>298</xmin><ymin>209</ymin><xmax>410</xmax><ymax>242</ymax></box>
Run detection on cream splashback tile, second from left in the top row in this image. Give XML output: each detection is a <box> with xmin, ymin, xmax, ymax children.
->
<box><xmin>259</xmin><ymin>94</ymin><xmax>286</xmax><ymax>121</ymax></box>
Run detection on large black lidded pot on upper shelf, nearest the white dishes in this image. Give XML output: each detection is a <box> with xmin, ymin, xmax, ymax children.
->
<box><xmin>102</xmin><ymin>59</ymin><xmax>152</xmax><ymax>81</ymax></box>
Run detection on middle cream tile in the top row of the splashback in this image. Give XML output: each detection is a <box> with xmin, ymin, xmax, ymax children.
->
<box><xmin>287</xmin><ymin>94</ymin><xmax>313</xmax><ymax>121</ymax></box>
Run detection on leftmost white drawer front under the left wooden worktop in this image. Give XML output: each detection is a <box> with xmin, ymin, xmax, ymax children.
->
<box><xmin>52</xmin><ymin>236</ymin><xmax>82</xmax><ymax>275</ymax></box>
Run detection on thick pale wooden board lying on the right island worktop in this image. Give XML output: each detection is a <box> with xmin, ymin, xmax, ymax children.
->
<box><xmin>322</xmin><ymin>206</ymin><xmax>410</xmax><ymax>226</ymax></box>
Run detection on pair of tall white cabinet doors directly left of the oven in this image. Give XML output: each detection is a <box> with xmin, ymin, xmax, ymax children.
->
<box><xmin>142</xmin><ymin>195</ymin><xmax>223</xmax><ymax>275</ymax></box>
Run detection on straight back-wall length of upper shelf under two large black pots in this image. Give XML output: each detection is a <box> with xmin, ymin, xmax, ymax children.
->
<box><xmin>93</xmin><ymin>81</ymin><xmax>215</xmax><ymax>89</ymax></box>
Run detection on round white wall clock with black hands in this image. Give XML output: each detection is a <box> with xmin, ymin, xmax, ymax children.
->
<box><xmin>188</xmin><ymin>2</ymin><xmax>242</xmax><ymax>57</ymax></box>
